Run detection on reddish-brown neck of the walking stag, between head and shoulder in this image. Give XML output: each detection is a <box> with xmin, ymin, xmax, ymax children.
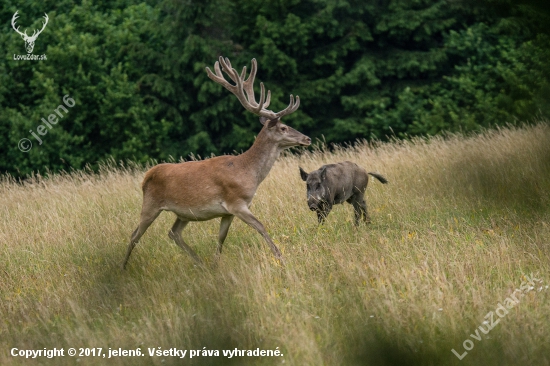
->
<box><xmin>241</xmin><ymin>129</ymin><xmax>282</xmax><ymax>185</ymax></box>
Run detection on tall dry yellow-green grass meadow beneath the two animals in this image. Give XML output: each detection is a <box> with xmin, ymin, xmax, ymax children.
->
<box><xmin>0</xmin><ymin>123</ymin><xmax>550</xmax><ymax>365</ymax></box>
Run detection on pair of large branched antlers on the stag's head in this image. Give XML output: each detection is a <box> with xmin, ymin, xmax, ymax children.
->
<box><xmin>206</xmin><ymin>56</ymin><xmax>300</xmax><ymax>119</ymax></box>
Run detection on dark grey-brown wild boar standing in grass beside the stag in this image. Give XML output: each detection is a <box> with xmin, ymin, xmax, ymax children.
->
<box><xmin>300</xmin><ymin>161</ymin><xmax>388</xmax><ymax>225</ymax></box>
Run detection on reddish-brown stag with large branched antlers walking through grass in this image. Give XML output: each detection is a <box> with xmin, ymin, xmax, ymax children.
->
<box><xmin>122</xmin><ymin>57</ymin><xmax>311</xmax><ymax>269</ymax></box>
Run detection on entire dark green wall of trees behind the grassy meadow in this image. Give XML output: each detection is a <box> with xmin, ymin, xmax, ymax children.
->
<box><xmin>0</xmin><ymin>0</ymin><xmax>550</xmax><ymax>176</ymax></box>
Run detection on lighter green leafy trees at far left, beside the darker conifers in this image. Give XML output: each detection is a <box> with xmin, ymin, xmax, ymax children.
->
<box><xmin>0</xmin><ymin>2</ymin><xmax>167</xmax><ymax>174</ymax></box>
